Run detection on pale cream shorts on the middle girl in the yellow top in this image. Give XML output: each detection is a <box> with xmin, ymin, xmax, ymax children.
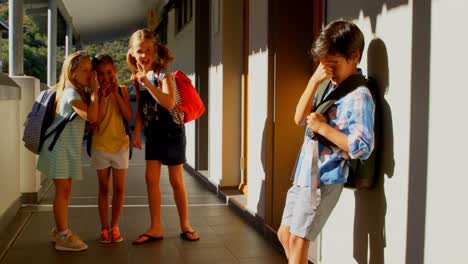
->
<box><xmin>91</xmin><ymin>147</ymin><xmax>129</xmax><ymax>170</ymax></box>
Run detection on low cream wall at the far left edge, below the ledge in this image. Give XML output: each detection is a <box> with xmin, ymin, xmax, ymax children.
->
<box><xmin>0</xmin><ymin>100</ymin><xmax>21</xmax><ymax>217</ymax></box>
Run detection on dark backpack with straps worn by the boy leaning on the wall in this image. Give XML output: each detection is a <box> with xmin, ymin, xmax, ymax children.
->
<box><xmin>312</xmin><ymin>74</ymin><xmax>380</xmax><ymax>189</ymax></box>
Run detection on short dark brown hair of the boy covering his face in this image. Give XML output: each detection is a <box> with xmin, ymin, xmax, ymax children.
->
<box><xmin>310</xmin><ymin>19</ymin><xmax>364</xmax><ymax>61</ymax></box>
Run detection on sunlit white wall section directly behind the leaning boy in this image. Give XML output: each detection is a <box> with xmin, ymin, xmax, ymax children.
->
<box><xmin>321</xmin><ymin>0</ymin><xmax>417</xmax><ymax>263</ymax></box>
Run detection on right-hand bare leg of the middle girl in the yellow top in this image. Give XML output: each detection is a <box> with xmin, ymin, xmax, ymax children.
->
<box><xmin>111</xmin><ymin>169</ymin><xmax>127</xmax><ymax>227</ymax></box>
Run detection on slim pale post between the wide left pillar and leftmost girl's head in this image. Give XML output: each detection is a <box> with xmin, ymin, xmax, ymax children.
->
<box><xmin>47</xmin><ymin>0</ymin><xmax>57</xmax><ymax>86</ymax></box>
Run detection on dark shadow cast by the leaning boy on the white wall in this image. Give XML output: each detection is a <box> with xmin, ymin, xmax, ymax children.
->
<box><xmin>353</xmin><ymin>38</ymin><xmax>395</xmax><ymax>264</ymax></box>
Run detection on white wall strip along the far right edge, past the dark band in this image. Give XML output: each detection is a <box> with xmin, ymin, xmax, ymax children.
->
<box><xmin>425</xmin><ymin>0</ymin><xmax>468</xmax><ymax>263</ymax></box>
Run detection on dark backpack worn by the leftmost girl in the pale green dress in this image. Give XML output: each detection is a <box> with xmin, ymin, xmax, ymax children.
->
<box><xmin>23</xmin><ymin>88</ymin><xmax>76</xmax><ymax>154</ymax></box>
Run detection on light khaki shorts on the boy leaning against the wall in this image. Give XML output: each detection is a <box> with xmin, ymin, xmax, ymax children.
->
<box><xmin>281</xmin><ymin>184</ymin><xmax>343</xmax><ymax>241</ymax></box>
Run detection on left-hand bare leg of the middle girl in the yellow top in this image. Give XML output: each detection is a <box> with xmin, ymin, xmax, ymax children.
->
<box><xmin>97</xmin><ymin>168</ymin><xmax>110</xmax><ymax>229</ymax></box>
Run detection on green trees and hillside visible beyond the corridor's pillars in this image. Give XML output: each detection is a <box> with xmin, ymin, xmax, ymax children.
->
<box><xmin>0</xmin><ymin>3</ymin><xmax>130</xmax><ymax>85</ymax></box>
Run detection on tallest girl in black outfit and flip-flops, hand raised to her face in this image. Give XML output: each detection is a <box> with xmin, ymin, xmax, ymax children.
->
<box><xmin>127</xmin><ymin>29</ymin><xmax>200</xmax><ymax>245</ymax></box>
